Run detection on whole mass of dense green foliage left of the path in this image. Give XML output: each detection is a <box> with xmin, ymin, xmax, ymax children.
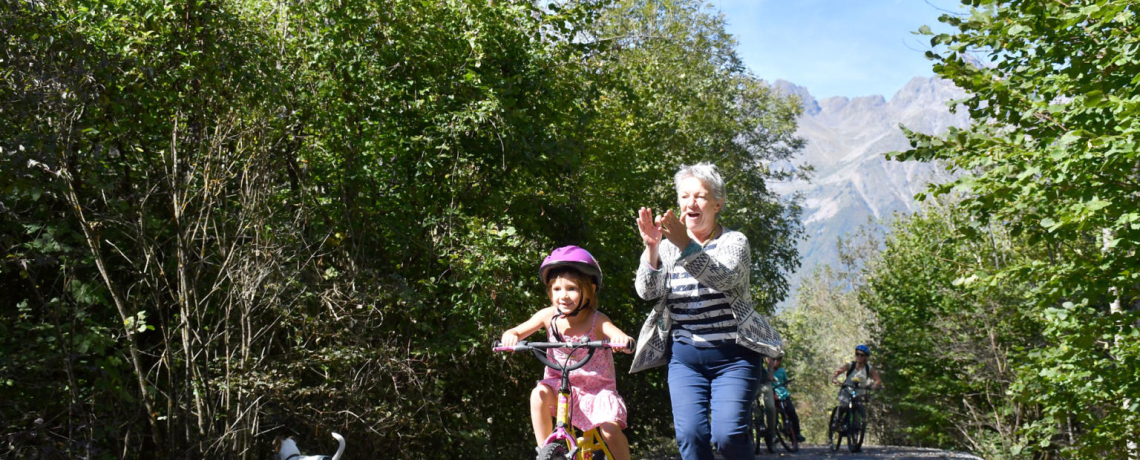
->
<box><xmin>0</xmin><ymin>0</ymin><xmax>800</xmax><ymax>458</ymax></box>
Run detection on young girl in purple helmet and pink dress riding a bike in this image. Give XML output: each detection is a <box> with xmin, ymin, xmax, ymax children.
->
<box><xmin>502</xmin><ymin>246</ymin><xmax>634</xmax><ymax>460</ymax></box>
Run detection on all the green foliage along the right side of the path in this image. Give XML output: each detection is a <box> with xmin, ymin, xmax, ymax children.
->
<box><xmin>868</xmin><ymin>0</ymin><xmax>1140</xmax><ymax>459</ymax></box>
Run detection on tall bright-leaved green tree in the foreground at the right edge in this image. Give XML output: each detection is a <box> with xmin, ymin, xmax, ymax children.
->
<box><xmin>895</xmin><ymin>0</ymin><xmax>1140</xmax><ymax>458</ymax></box>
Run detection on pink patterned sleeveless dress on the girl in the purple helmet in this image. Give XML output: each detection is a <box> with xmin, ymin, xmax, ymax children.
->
<box><xmin>539</xmin><ymin>311</ymin><xmax>627</xmax><ymax>430</ymax></box>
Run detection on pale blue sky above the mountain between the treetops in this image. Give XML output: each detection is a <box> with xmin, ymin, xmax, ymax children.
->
<box><xmin>708</xmin><ymin>0</ymin><xmax>960</xmax><ymax>99</ymax></box>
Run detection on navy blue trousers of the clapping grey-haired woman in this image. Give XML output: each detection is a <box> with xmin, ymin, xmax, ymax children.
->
<box><xmin>669</xmin><ymin>342</ymin><xmax>762</xmax><ymax>460</ymax></box>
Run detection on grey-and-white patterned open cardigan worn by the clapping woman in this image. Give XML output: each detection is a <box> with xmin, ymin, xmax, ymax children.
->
<box><xmin>629</xmin><ymin>229</ymin><xmax>783</xmax><ymax>373</ymax></box>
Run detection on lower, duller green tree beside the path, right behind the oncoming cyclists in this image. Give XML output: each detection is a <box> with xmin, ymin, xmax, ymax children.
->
<box><xmin>857</xmin><ymin>199</ymin><xmax>1043</xmax><ymax>459</ymax></box>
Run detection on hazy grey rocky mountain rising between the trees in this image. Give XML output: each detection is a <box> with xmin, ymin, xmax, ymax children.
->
<box><xmin>773</xmin><ymin>77</ymin><xmax>969</xmax><ymax>298</ymax></box>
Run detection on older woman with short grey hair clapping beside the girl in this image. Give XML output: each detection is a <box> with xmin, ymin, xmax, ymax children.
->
<box><xmin>630</xmin><ymin>163</ymin><xmax>781</xmax><ymax>460</ymax></box>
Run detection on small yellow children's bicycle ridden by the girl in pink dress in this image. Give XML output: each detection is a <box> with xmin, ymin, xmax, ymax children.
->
<box><xmin>494</xmin><ymin>340</ymin><xmax>614</xmax><ymax>460</ymax></box>
